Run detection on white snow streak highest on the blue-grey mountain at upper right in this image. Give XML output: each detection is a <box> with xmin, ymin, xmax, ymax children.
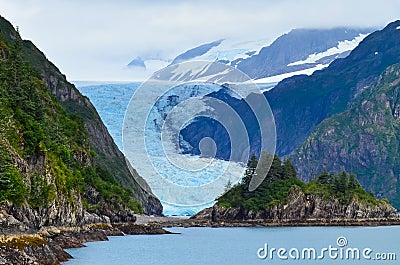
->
<box><xmin>287</xmin><ymin>34</ymin><xmax>368</xmax><ymax>66</ymax></box>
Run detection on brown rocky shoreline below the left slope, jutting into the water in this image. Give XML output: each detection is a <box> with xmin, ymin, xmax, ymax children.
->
<box><xmin>0</xmin><ymin>223</ymin><xmax>171</xmax><ymax>265</ymax></box>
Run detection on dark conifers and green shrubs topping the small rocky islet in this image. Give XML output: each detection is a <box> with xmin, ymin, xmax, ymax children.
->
<box><xmin>217</xmin><ymin>154</ymin><xmax>379</xmax><ymax>211</ymax></box>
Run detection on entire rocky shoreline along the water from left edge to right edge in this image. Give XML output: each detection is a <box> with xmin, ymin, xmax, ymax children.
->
<box><xmin>0</xmin><ymin>216</ymin><xmax>400</xmax><ymax>265</ymax></box>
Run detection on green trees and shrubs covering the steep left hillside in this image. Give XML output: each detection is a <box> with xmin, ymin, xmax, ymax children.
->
<box><xmin>0</xmin><ymin>29</ymin><xmax>143</xmax><ymax>212</ymax></box>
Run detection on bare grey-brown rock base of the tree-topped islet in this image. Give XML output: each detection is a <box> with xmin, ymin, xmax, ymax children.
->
<box><xmin>193</xmin><ymin>188</ymin><xmax>398</xmax><ymax>221</ymax></box>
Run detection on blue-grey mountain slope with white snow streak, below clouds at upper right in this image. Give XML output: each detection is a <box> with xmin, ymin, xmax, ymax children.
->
<box><xmin>235</xmin><ymin>28</ymin><xmax>372</xmax><ymax>79</ymax></box>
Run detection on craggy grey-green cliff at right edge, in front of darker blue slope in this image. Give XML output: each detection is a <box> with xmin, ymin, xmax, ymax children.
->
<box><xmin>291</xmin><ymin>64</ymin><xmax>400</xmax><ymax>208</ymax></box>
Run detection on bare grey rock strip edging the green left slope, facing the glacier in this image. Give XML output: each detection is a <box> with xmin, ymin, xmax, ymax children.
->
<box><xmin>19</xmin><ymin>37</ymin><xmax>162</xmax><ymax>215</ymax></box>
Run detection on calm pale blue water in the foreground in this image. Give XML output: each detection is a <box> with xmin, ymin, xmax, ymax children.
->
<box><xmin>65</xmin><ymin>226</ymin><xmax>400</xmax><ymax>265</ymax></box>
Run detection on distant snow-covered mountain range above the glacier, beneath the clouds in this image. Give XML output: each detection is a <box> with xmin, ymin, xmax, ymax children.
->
<box><xmin>131</xmin><ymin>28</ymin><xmax>373</xmax><ymax>83</ymax></box>
